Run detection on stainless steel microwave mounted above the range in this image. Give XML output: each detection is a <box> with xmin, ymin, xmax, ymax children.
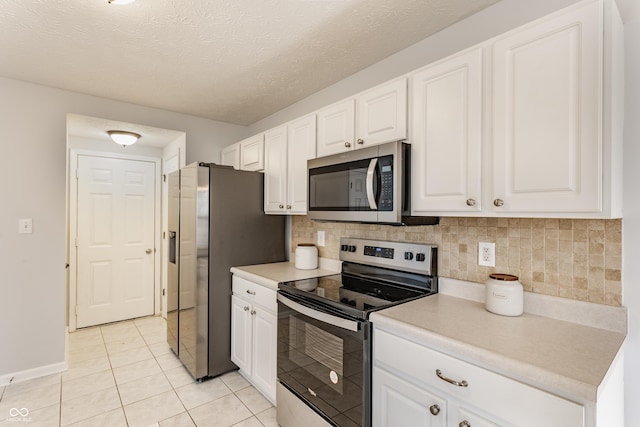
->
<box><xmin>307</xmin><ymin>141</ymin><xmax>439</xmax><ymax>225</ymax></box>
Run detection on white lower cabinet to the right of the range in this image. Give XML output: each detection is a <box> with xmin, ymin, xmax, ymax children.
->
<box><xmin>372</xmin><ymin>328</ymin><xmax>585</xmax><ymax>427</ymax></box>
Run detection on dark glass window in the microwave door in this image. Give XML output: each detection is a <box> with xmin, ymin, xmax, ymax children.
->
<box><xmin>309</xmin><ymin>156</ymin><xmax>382</xmax><ymax>211</ymax></box>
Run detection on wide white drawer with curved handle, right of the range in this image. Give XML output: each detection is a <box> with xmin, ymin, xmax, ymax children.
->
<box><xmin>373</xmin><ymin>329</ymin><xmax>584</xmax><ymax>427</ymax></box>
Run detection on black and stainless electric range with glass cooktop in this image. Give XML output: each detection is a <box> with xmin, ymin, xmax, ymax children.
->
<box><xmin>276</xmin><ymin>238</ymin><xmax>438</xmax><ymax>427</ymax></box>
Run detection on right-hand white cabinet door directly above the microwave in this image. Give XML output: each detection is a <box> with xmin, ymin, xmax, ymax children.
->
<box><xmin>356</xmin><ymin>79</ymin><xmax>407</xmax><ymax>148</ymax></box>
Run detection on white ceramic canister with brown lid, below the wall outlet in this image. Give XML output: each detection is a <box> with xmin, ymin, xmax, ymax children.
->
<box><xmin>485</xmin><ymin>273</ymin><xmax>524</xmax><ymax>316</ymax></box>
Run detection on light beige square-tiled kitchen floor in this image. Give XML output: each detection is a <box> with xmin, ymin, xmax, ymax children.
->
<box><xmin>0</xmin><ymin>317</ymin><xmax>278</xmax><ymax>427</ymax></box>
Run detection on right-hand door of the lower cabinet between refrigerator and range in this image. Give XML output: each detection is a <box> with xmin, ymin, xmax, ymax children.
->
<box><xmin>251</xmin><ymin>305</ymin><xmax>278</xmax><ymax>401</ymax></box>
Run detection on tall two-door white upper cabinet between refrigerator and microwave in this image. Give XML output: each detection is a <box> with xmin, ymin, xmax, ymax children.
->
<box><xmin>264</xmin><ymin>114</ymin><xmax>316</xmax><ymax>214</ymax></box>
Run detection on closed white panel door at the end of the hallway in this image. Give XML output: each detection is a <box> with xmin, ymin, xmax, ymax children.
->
<box><xmin>76</xmin><ymin>155</ymin><xmax>155</xmax><ymax>328</ymax></box>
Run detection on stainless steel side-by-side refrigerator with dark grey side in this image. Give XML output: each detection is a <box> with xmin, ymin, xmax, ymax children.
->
<box><xmin>167</xmin><ymin>163</ymin><xmax>286</xmax><ymax>380</ymax></box>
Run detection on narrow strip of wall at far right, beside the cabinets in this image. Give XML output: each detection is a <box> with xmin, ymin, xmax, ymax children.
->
<box><xmin>622</xmin><ymin>20</ymin><xmax>640</xmax><ymax>426</ymax></box>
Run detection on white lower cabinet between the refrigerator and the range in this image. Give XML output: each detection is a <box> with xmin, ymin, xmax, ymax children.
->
<box><xmin>231</xmin><ymin>276</ymin><xmax>278</xmax><ymax>403</ymax></box>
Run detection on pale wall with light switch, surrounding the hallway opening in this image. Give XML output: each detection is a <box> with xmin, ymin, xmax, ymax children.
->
<box><xmin>0</xmin><ymin>78</ymin><xmax>248</xmax><ymax>384</ymax></box>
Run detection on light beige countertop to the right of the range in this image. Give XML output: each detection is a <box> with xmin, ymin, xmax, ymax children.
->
<box><xmin>371</xmin><ymin>294</ymin><xmax>625</xmax><ymax>402</ymax></box>
